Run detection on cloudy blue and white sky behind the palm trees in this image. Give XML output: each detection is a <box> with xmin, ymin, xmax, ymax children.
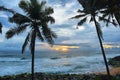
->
<box><xmin>0</xmin><ymin>0</ymin><xmax>120</xmax><ymax>51</ymax></box>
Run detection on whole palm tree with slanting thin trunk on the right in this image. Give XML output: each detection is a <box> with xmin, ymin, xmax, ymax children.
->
<box><xmin>72</xmin><ymin>0</ymin><xmax>117</xmax><ymax>80</ymax></box>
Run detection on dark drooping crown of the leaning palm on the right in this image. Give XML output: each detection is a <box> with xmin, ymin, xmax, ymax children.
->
<box><xmin>72</xmin><ymin>0</ymin><xmax>120</xmax><ymax>39</ymax></box>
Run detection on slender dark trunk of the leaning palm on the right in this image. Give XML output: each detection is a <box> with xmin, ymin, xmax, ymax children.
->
<box><xmin>93</xmin><ymin>16</ymin><xmax>111</xmax><ymax>80</ymax></box>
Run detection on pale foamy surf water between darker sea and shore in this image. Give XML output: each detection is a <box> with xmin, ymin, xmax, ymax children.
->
<box><xmin>0</xmin><ymin>54</ymin><xmax>119</xmax><ymax>76</ymax></box>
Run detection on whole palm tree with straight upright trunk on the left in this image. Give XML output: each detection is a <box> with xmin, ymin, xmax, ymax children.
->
<box><xmin>6</xmin><ymin>0</ymin><xmax>57</xmax><ymax>80</ymax></box>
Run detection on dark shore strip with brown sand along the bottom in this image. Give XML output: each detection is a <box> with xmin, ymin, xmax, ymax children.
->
<box><xmin>0</xmin><ymin>67</ymin><xmax>120</xmax><ymax>80</ymax></box>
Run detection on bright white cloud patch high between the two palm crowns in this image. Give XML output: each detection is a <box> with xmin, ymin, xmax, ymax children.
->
<box><xmin>52</xmin><ymin>2</ymin><xmax>76</xmax><ymax>25</ymax></box>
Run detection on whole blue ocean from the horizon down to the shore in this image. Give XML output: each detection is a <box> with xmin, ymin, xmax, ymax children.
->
<box><xmin>0</xmin><ymin>49</ymin><xmax>120</xmax><ymax>76</ymax></box>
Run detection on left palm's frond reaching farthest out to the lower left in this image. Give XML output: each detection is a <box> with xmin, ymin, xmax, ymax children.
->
<box><xmin>6</xmin><ymin>24</ymin><xmax>28</xmax><ymax>39</ymax></box>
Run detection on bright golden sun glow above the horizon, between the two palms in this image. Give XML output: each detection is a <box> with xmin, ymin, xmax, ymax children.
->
<box><xmin>52</xmin><ymin>45</ymin><xmax>80</xmax><ymax>52</ymax></box>
